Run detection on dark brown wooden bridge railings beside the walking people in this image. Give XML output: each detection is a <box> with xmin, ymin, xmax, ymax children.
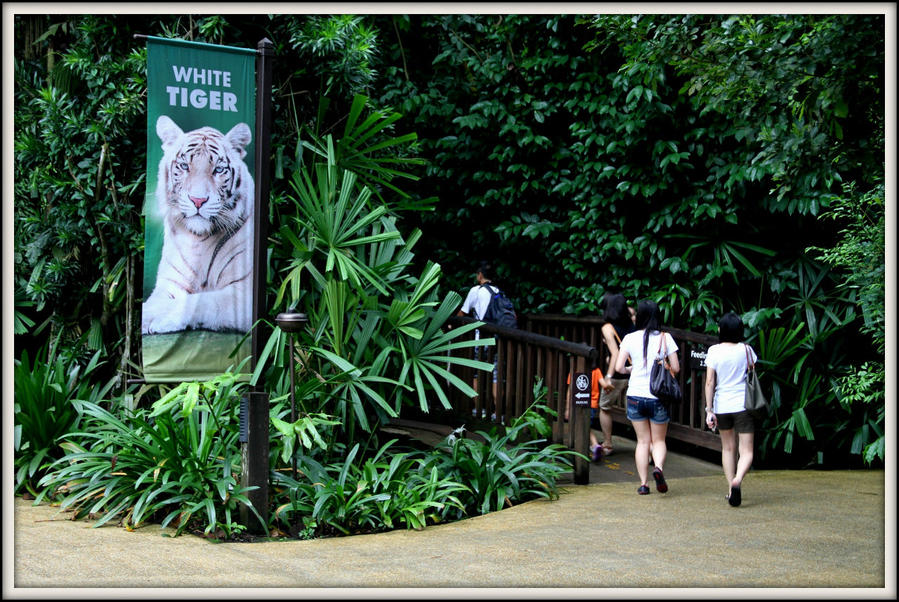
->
<box><xmin>404</xmin><ymin>314</ymin><xmax>721</xmax><ymax>483</ymax></box>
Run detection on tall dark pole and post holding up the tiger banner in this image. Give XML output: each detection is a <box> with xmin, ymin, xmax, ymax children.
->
<box><xmin>240</xmin><ymin>38</ymin><xmax>274</xmax><ymax>531</ymax></box>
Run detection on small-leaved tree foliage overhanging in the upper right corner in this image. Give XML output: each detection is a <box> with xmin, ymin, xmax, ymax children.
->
<box><xmin>595</xmin><ymin>15</ymin><xmax>883</xmax><ymax>215</ymax></box>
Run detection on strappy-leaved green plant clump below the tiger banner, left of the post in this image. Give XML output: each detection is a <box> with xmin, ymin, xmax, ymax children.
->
<box><xmin>36</xmin><ymin>373</ymin><xmax>261</xmax><ymax>535</ymax></box>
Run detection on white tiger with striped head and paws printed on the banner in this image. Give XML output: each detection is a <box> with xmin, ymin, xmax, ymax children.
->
<box><xmin>141</xmin><ymin>115</ymin><xmax>254</xmax><ymax>334</ymax></box>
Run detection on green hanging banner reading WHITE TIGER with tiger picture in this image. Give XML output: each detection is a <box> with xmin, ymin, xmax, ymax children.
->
<box><xmin>141</xmin><ymin>36</ymin><xmax>256</xmax><ymax>382</ymax></box>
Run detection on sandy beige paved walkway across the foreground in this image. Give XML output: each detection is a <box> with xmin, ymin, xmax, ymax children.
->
<box><xmin>3</xmin><ymin>428</ymin><xmax>896</xmax><ymax>599</ymax></box>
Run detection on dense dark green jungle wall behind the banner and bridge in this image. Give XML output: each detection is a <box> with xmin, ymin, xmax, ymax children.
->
<box><xmin>14</xmin><ymin>14</ymin><xmax>886</xmax><ymax>516</ymax></box>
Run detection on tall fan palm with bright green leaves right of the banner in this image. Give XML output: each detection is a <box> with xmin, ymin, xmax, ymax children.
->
<box><xmin>252</xmin><ymin>124</ymin><xmax>490</xmax><ymax>447</ymax></box>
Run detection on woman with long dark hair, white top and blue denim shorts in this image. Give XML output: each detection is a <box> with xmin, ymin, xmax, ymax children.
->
<box><xmin>615</xmin><ymin>300</ymin><xmax>680</xmax><ymax>495</ymax></box>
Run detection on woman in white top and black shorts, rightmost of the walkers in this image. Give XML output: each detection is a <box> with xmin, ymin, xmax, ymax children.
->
<box><xmin>705</xmin><ymin>312</ymin><xmax>758</xmax><ymax>506</ymax></box>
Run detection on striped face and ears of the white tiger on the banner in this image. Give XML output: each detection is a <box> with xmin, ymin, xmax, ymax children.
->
<box><xmin>156</xmin><ymin>115</ymin><xmax>252</xmax><ymax>237</ymax></box>
